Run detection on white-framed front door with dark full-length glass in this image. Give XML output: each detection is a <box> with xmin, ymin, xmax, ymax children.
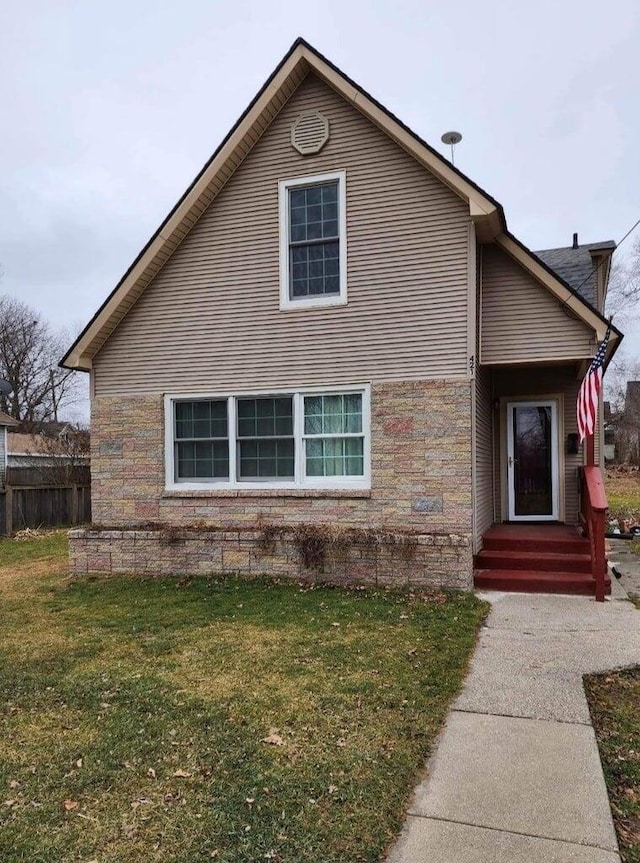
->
<box><xmin>507</xmin><ymin>401</ymin><xmax>559</xmax><ymax>521</ymax></box>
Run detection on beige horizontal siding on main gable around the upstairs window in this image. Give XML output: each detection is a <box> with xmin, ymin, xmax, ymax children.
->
<box><xmin>94</xmin><ymin>76</ymin><xmax>469</xmax><ymax>396</ymax></box>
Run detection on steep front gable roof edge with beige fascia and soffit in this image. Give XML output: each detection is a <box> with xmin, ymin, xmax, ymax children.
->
<box><xmin>61</xmin><ymin>38</ymin><xmax>620</xmax><ymax>371</ymax></box>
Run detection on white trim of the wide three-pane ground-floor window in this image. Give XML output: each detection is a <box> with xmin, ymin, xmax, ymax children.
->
<box><xmin>164</xmin><ymin>384</ymin><xmax>371</xmax><ymax>491</ymax></box>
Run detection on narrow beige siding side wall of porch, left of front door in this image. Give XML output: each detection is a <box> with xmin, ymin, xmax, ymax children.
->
<box><xmin>474</xmin><ymin>366</ymin><xmax>494</xmax><ymax>548</ymax></box>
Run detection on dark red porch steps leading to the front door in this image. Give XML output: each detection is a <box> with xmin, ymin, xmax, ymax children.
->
<box><xmin>473</xmin><ymin>524</ymin><xmax>611</xmax><ymax>596</ymax></box>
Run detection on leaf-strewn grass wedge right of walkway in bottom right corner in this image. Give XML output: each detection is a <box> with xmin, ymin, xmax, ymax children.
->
<box><xmin>585</xmin><ymin>667</ymin><xmax>640</xmax><ymax>863</ymax></box>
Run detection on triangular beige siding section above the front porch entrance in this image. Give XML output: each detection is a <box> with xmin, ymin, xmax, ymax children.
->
<box><xmin>480</xmin><ymin>244</ymin><xmax>595</xmax><ymax>363</ymax></box>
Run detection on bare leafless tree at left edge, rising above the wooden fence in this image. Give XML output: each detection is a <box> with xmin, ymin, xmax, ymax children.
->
<box><xmin>0</xmin><ymin>296</ymin><xmax>76</xmax><ymax>430</ymax></box>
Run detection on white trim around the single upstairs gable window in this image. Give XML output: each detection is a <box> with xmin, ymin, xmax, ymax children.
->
<box><xmin>278</xmin><ymin>171</ymin><xmax>347</xmax><ymax>311</ymax></box>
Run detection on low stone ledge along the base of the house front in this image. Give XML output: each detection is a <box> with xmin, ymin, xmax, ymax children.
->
<box><xmin>69</xmin><ymin>528</ymin><xmax>472</xmax><ymax>589</ymax></box>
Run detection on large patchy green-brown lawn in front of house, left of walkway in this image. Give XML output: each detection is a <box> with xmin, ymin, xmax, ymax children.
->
<box><xmin>0</xmin><ymin>535</ymin><xmax>486</xmax><ymax>863</ymax></box>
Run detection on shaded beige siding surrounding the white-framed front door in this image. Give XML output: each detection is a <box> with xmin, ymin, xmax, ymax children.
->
<box><xmin>493</xmin><ymin>365</ymin><xmax>582</xmax><ymax>524</ymax></box>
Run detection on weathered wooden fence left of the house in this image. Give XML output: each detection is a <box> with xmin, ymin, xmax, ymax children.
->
<box><xmin>0</xmin><ymin>485</ymin><xmax>91</xmax><ymax>535</ymax></box>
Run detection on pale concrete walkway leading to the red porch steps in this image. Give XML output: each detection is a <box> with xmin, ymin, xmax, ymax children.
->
<box><xmin>388</xmin><ymin>586</ymin><xmax>640</xmax><ymax>863</ymax></box>
